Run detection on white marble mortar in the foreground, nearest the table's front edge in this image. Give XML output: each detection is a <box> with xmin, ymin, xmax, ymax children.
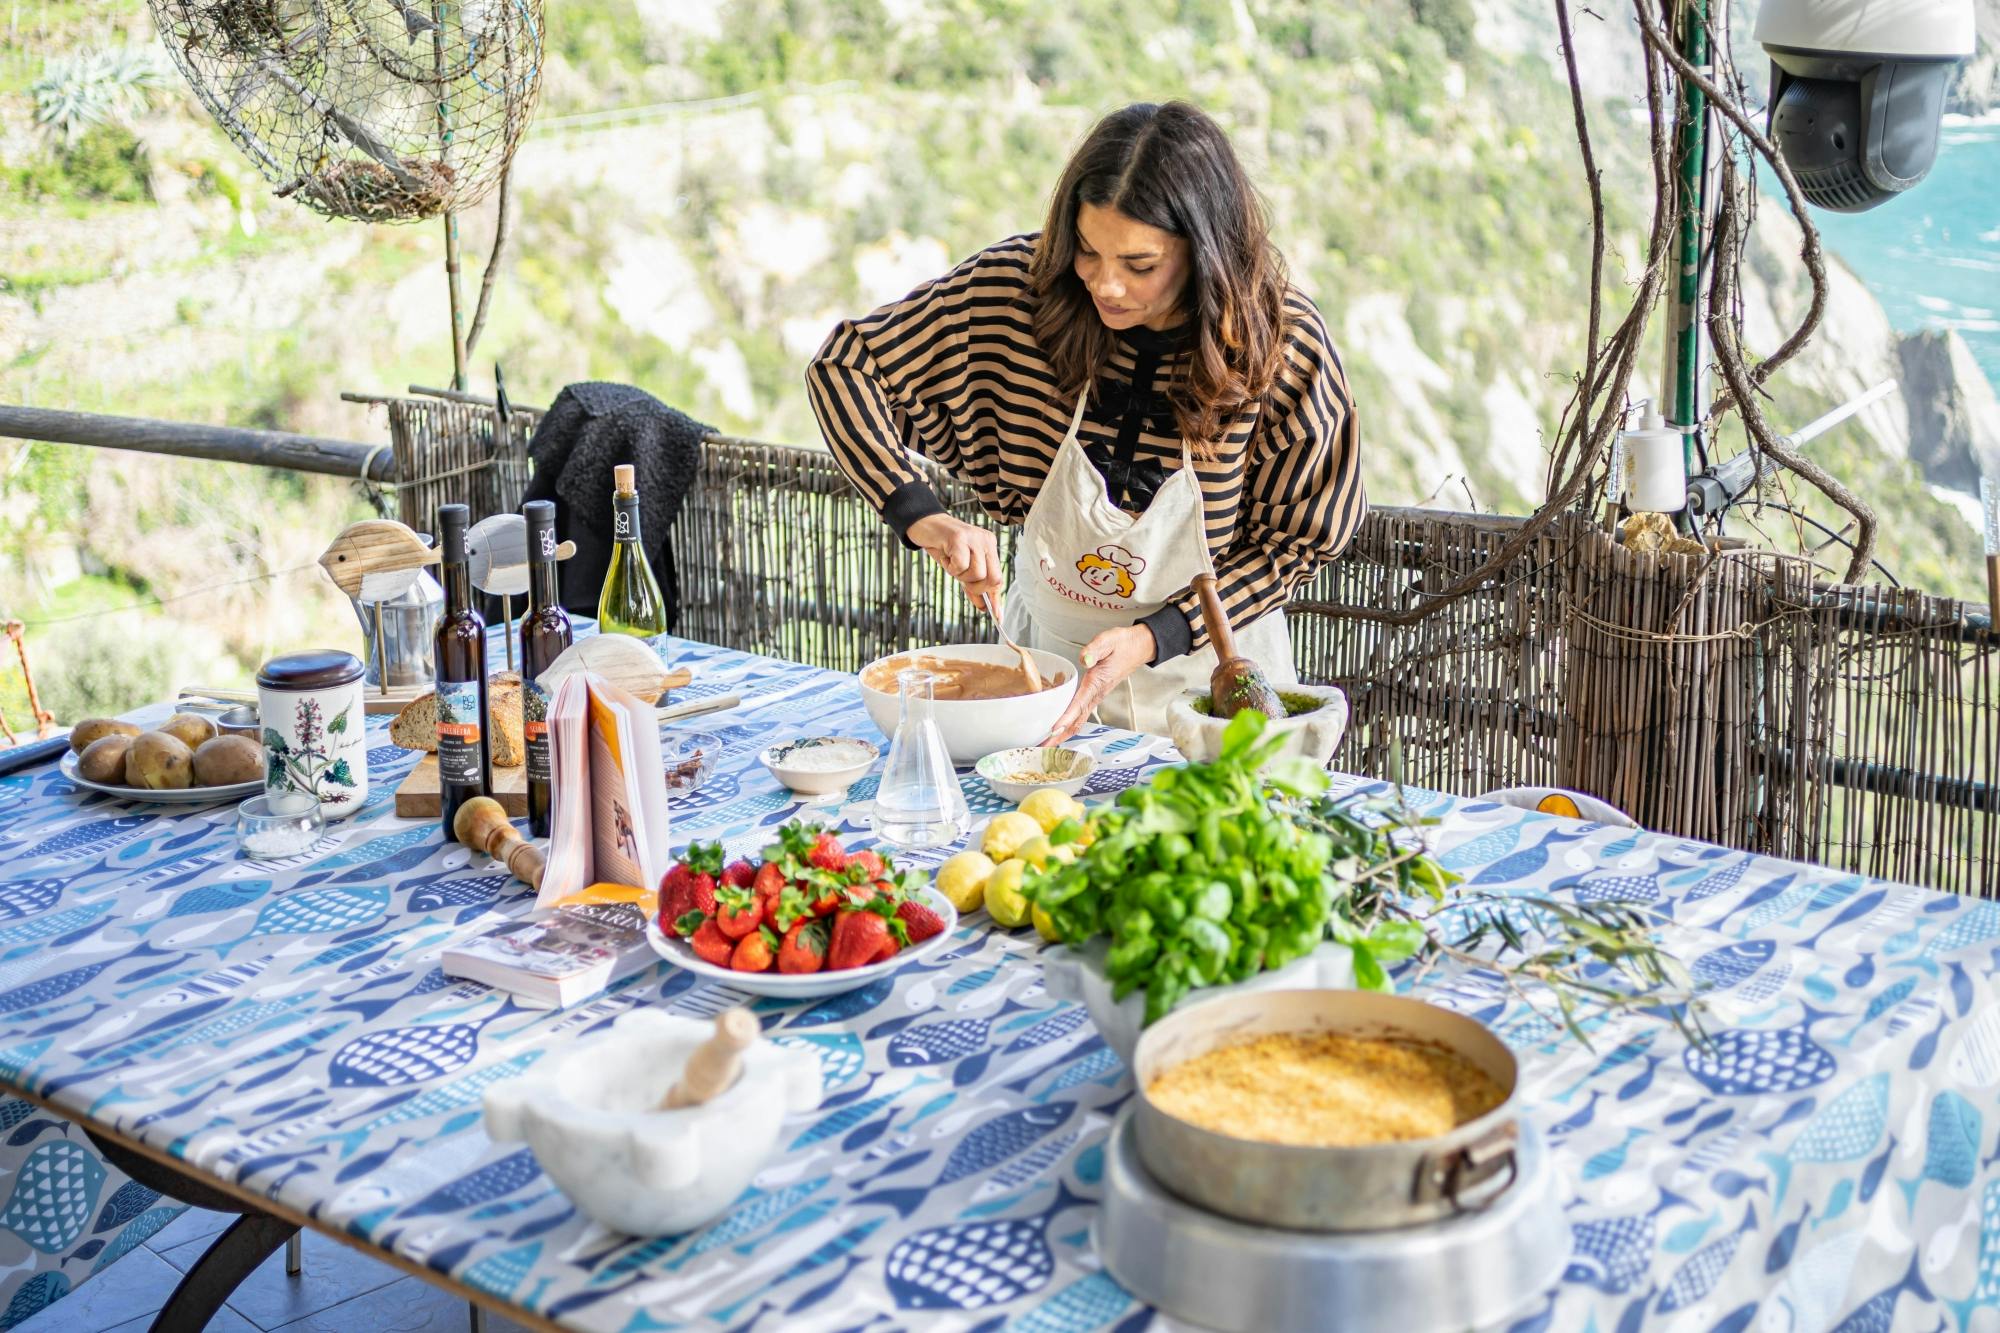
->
<box><xmin>486</xmin><ymin>1009</ymin><xmax>820</xmax><ymax>1235</ymax></box>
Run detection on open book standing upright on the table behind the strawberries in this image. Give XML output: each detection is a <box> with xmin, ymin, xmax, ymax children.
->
<box><xmin>534</xmin><ymin>673</ymin><xmax>668</xmax><ymax>907</ymax></box>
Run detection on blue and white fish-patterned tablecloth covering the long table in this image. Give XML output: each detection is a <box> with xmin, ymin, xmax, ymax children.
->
<box><xmin>0</xmin><ymin>644</ymin><xmax>2000</xmax><ymax>1333</ymax></box>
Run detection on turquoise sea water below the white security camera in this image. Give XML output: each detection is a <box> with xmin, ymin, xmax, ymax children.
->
<box><xmin>1800</xmin><ymin>116</ymin><xmax>2000</xmax><ymax>384</ymax></box>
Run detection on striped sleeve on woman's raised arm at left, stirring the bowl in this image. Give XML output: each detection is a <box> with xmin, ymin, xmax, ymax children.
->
<box><xmin>806</xmin><ymin>246</ymin><xmax>1018</xmax><ymax>542</ymax></box>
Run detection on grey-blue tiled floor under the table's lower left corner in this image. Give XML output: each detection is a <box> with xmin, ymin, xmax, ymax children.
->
<box><xmin>14</xmin><ymin>1209</ymin><xmax>540</xmax><ymax>1333</ymax></box>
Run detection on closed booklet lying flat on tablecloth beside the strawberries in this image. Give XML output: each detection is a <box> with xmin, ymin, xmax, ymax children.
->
<box><xmin>438</xmin><ymin>885</ymin><xmax>658</xmax><ymax>1009</ymax></box>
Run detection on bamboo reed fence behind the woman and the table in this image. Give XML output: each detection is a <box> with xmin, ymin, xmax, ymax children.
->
<box><xmin>672</xmin><ymin>438</ymin><xmax>2000</xmax><ymax>897</ymax></box>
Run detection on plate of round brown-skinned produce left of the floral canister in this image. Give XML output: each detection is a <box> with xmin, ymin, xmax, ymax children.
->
<box><xmin>60</xmin><ymin>713</ymin><xmax>264</xmax><ymax>805</ymax></box>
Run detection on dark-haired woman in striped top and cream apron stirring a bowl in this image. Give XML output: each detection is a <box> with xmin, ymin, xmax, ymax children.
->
<box><xmin>806</xmin><ymin>102</ymin><xmax>1366</xmax><ymax>743</ymax></box>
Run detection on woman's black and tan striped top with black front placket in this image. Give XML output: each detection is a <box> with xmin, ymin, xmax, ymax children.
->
<box><xmin>806</xmin><ymin>234</ymin><xmax>1366</xmax><ymax>660</ymax></box>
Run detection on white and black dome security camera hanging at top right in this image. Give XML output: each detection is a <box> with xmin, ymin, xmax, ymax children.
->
<box><xmin>1756</xmin><ymin>0</ymin><xmax>1974</xmax><ymax>212</ymax></box>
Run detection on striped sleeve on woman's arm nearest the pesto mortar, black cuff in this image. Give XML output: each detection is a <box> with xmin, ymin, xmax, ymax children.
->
<box><xmin>1174</xmin><ymin>294</ymin><xmax>1368</xmax><ymax>648</ymax></box>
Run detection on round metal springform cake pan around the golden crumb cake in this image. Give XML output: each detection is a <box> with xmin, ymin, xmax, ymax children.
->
<box><xmin>1132</xmin><ymin>991</ymin><xmax>1520</xmax><ymax>1231</ymax></box>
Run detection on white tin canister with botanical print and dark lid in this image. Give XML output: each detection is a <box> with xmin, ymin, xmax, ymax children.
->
<box><xmin>256</xmin><ymin>648</ymin><xmax>368</xmax><ymax>819</ymax></box>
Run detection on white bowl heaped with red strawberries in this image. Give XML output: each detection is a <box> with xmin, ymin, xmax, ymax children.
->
<box><xmin>646</xmin><ymin>823</ymin><xmax>958</xmax><ymax>999</ymax></box>
